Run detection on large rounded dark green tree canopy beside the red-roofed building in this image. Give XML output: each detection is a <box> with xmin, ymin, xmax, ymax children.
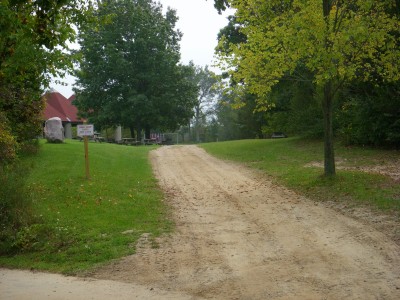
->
<box><xmin>76</xmin><ymin>0</ymin><xmax>197</xmax><ymax>132</ymax></box>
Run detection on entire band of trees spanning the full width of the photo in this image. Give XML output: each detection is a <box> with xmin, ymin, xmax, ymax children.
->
<box><xmin>0</xmin><ymin>0</ymin><xmax>400</xmax><ymax>175</ymax></box>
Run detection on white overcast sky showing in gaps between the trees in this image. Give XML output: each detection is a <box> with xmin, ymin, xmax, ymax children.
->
<box><xmin>51</xmin><ymin>0</ymin><xmax>228</xmax><ymax>98</ymax></box>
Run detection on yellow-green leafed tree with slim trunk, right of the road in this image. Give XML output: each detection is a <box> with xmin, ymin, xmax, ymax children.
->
<box><xmin>216</xmin><ymin>0</ymin><xmax>400</xmax><ymax>176</ymax></box>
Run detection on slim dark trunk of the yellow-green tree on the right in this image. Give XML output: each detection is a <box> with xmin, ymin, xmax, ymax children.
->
<box><xmin>322</xmin><ymin>81</ymin><xmax>336</xmax><ymax>177</ymax></box>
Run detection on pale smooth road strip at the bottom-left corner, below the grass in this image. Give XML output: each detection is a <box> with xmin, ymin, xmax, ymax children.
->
<box><xmin>0</xmin><ymin>269</ymin><xmax>190</xmax><ymax>300</ymax></box>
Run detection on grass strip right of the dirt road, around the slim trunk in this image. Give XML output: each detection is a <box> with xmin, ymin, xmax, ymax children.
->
<box><xmin>202</xmin><ymin>138</ymin><xmax>400</xmax><ymax>214</ymax></box>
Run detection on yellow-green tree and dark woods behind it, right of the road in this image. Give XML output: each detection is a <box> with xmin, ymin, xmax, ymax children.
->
<box><xmin>209</xmin><ymin>0</ymin><xmax>400</xmax><ymax>176</ymax></box>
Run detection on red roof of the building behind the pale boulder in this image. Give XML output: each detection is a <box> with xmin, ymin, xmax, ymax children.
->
<box><xmin>44</xmin><ymin>92</ymin><xmax>82</xmax><ymax>123</ymax></box>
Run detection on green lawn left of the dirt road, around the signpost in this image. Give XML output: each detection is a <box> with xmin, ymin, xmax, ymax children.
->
<box><xmin>0</xmin><ymin>140</ymin><xmax>172</xmax><ymax>273</ymax></box>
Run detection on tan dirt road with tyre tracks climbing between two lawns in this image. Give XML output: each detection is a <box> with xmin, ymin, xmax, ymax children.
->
<box><xmin>0</xmin><ymin>146</ymin><xmax>400</xmax><ymax>300</ymax></box>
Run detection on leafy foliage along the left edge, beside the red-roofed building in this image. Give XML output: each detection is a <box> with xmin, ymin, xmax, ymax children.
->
<box><xmin>0</xmin><ymin>0</ymin><xmax>90</xmax><ymax>163</ymax></box>
